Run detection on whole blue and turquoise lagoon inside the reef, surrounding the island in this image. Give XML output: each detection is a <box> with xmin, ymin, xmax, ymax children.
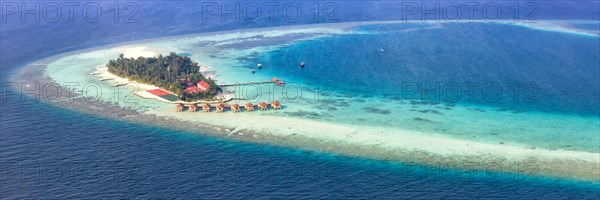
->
<box><xmin>46</xmin><ymin>22</ymin><xmax>600</xmax><ymax>166</ymax></box>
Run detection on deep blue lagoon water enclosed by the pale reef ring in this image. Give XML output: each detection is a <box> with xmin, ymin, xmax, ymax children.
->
<box><xmin>260</xmin><ymin>23</ymin><xmax>600</xmax><ymax>116</ymax></box>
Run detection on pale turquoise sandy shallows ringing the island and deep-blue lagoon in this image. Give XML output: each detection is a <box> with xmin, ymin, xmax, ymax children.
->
<box><xmin>13</xmin><ymin>22</ymin><xmax>600</xmax><ymax>182</ymax></box>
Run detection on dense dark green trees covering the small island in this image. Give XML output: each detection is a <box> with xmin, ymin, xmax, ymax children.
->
<box><xmin>106</xmin><ymin>53</ymin><xmax>221</xmax><ymax>101</ymax></box>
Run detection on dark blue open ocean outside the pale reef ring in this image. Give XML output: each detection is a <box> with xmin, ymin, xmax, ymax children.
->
<box><xmin>0</xmin><ymin>1</ymin><xmax>600</xmax><ymax>199</ymax></box>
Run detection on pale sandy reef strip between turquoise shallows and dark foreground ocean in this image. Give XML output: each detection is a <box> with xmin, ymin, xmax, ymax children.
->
<box><xmin>11</xmin><ymin>19</ymin><xmax>600</xmax><ymax>181</ymax></box>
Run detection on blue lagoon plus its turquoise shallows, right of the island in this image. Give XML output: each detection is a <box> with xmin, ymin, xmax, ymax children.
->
<box><xmin>210</xmin><ymin>23</ymin><xmax>600</xmax><ymax>152</ymax></box>
